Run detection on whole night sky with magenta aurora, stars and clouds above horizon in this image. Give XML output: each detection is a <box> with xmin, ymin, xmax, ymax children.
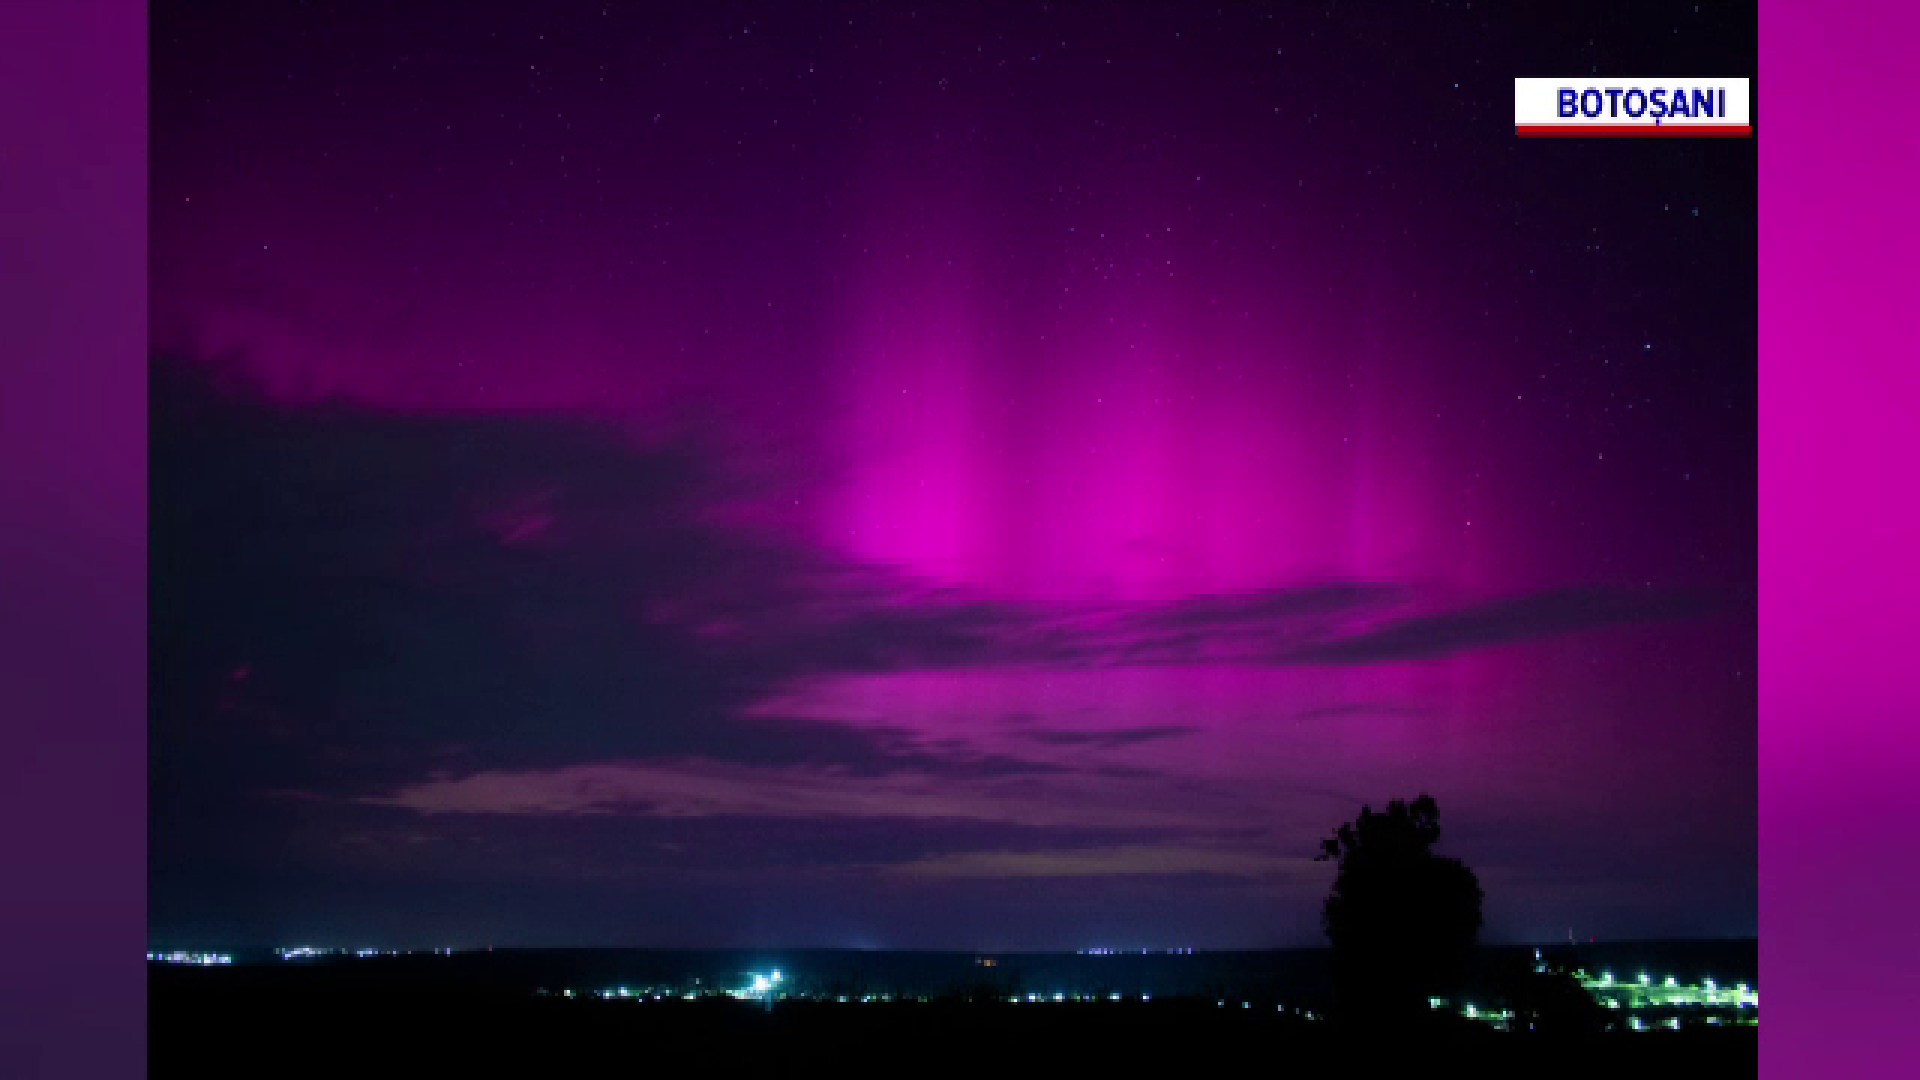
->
<box><xmin>150</xmin><ymin>0</ymin><xmax>1759</xmax><ymax>949</ymax></box>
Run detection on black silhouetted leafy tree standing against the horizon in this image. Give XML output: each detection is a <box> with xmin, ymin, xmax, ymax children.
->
<box><xmin>1317</xmin><ymin>794</ymin><xmax>1484</xmax><ymax>1024</ymax></box>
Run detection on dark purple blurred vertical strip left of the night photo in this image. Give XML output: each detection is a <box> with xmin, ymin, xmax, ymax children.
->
<box><xmin>0</xmin><ymin>0</ymin><xmax>146</xmax><ymax>1076</ymax></box>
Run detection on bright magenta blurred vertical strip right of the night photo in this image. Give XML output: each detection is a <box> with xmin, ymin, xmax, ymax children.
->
<box><xmin>1757</xmin><ymin>0</ymin><xmax>1920</xmax><ymax>1078</ymax></box>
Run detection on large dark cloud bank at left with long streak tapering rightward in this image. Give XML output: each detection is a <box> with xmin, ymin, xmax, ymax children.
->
<box><xmin>152</xmin><ymin>345</ymin><xmax>1713</xmax><ymax>788</ymax></box>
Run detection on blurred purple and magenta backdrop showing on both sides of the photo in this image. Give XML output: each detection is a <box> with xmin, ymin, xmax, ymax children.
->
<box><xmin>0</xmin><ymin>2</ymin><xmax>1920</xmax><ymax>1076</ymax></box>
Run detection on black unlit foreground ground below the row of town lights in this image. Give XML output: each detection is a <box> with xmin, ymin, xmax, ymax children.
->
<box><xmin>148</xmin><ymin>967</ymin><xmax>1757</xmax><ymax>1080</ymax></box>
